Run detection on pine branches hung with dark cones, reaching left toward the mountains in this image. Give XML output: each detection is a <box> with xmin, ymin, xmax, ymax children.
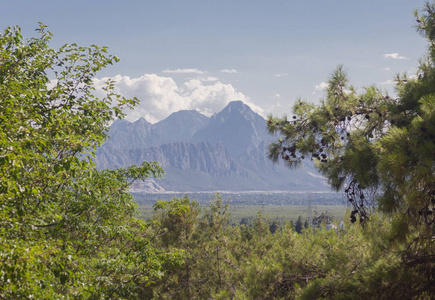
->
<box><xmin>267</xmin><ymin>66</ymin><xmax>388</xmax><ymax>224</ymax></box>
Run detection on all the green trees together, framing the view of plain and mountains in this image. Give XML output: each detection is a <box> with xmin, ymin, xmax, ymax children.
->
<box><xmin>0</xmin><ymin>2</ymin><xmax>435</xmax><ymax>299</ymax></box>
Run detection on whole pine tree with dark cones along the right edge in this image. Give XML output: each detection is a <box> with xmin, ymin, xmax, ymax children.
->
<box><xmin>267</xmin><ymin>2</ymin><xmax>435</xmax><ymax>297</ymax></box>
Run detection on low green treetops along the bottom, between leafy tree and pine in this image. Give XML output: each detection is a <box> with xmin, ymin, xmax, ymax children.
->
<box><xmin>142</xmin><ymin>197</ymin><xmax>416</xmax><ymax>299</ymax></box>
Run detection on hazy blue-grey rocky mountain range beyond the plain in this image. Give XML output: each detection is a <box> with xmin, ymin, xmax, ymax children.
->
<box><xmin>95</xmin><ymin>101</ymin><xmax>329</xmax><ymax>192</ymax></box>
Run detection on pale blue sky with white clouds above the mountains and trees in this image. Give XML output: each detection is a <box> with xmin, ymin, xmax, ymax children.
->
<box><xmin>0</xmin><ymin>0</ymin><xmax>426</xmax><ymax>123</ymax></box>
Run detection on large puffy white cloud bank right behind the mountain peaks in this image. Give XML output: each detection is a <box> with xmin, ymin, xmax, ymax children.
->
<box><xmin>94</xmin><ymin>74</ymin><xmax>264</xmax><ymax>123</ymax></box>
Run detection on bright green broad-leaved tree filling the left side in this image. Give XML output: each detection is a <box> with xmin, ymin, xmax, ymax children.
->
<box><xmin>0</xmin><ymin>24</ymin><xmax>176</xmax><ymax>299</ymax></box>
